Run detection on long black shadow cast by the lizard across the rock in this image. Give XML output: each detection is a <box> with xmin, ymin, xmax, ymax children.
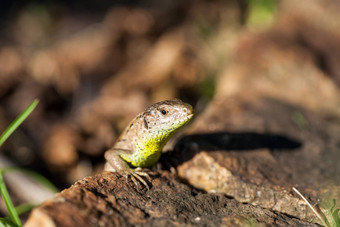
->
<box><xmin>162</xmin><ymin>132</ymin><xmax>302</xmax><ymax>166</ymax></box>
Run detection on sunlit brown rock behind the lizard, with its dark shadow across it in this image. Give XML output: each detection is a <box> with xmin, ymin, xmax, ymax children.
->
<box><xmin>173</xmin><ymin>96</ymin><xmax>340</xmax><ymax>222</ymax></box>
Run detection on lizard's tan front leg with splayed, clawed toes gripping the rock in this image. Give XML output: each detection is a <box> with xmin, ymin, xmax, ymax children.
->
<box><xmin>104</xmin><ymin>148</ymin><xmax>150</xmax><ymax>189</ymax></box>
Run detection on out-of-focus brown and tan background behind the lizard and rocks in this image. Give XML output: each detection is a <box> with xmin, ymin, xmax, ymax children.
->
<box><xmin>0</xmin><ymin>0</ymin><xmax>340</xmax><ymax>219</ymax></box>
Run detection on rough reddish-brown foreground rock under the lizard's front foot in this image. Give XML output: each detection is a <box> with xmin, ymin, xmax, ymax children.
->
<box><xmin>26</xmin><ymin>172</ymin><xmax>313</xmax><ymax>227</ymax></box>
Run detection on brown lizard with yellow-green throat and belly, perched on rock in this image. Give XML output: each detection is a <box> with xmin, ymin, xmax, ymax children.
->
<box><xmin>104</xmin><ymin>99</ymin><xmax>194</xmax><ymax>188</ymax></box>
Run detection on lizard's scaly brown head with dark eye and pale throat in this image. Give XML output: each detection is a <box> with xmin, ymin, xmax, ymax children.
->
<box><xmin>143</xmin><ymin>99</ymin><xmax>194</xmax><ymax>134</ymax></box>
